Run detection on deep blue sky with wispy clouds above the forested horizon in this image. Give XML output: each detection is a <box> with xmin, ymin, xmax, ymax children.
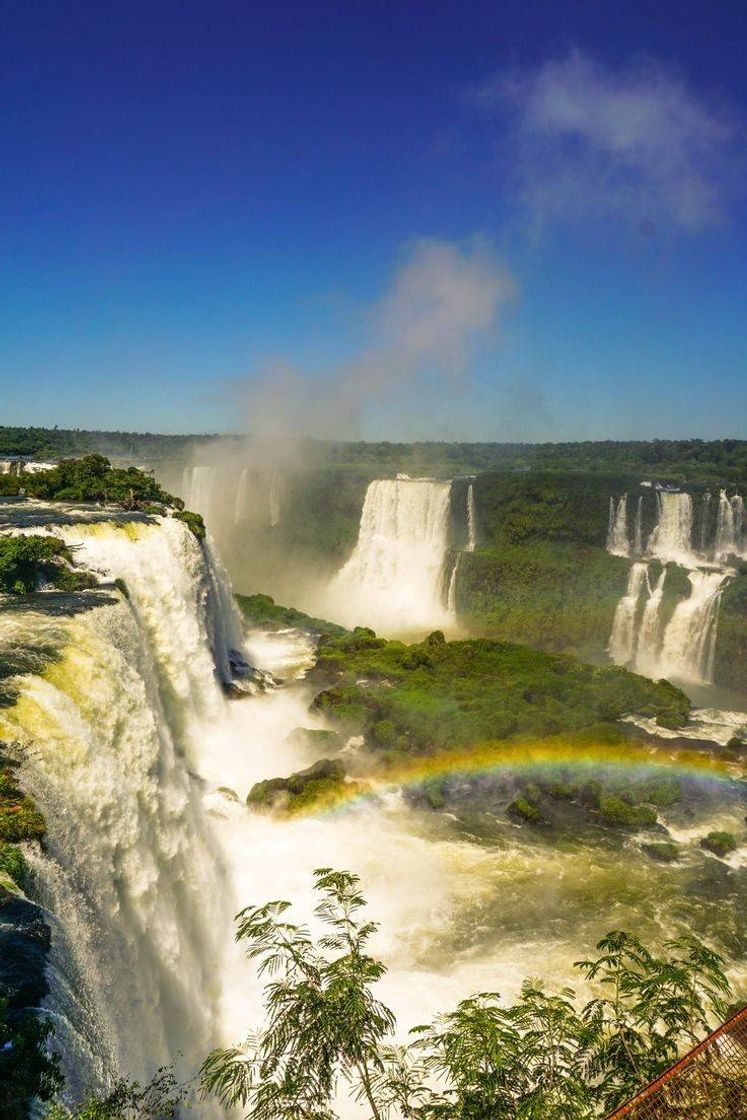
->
<box><xmin>0</xmin><ymin>0</ymin><xmax>747</xmax><ymax>439</ymax></box>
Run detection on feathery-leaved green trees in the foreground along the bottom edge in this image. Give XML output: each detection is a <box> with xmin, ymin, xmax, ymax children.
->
<box><xmin>202</xmin><ymin>868</ymin><xmax>730</xmax><ymax>1120</ymax></box>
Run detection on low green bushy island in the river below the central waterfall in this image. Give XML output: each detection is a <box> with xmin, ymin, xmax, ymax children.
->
<box><xmin>312</xmin><ymin>629</ymin><xmax>690</xmax><ymax>754</ymax></box>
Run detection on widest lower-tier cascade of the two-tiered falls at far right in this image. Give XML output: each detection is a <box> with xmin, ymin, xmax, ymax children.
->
<box><xmin>659</xmin><ymin>571</ymin><xmax>725</xmax><ymax>684</ymax></box>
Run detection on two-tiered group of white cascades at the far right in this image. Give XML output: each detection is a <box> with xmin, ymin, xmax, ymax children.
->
<box><xmin>607</xmin><ymin>491</ymin><xmax>745</xmax><ymax>683</ymax></box>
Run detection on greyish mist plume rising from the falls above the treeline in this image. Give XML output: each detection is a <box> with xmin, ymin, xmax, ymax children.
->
<box><xmin>240</xmin><ymin>240</ymin><xmax>515</xmax><ymax>444</ymax></box>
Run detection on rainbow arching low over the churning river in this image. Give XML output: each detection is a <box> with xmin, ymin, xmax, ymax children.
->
<box><xmin>291</xmin><ymin>736</ymin><xmax>747</xmax><ymax>815</ymax></box>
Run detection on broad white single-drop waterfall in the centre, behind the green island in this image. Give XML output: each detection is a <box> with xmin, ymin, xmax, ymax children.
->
<box><xmin>328</xmin><ymin>478</ymin><xmax>454</xmax><ymax>633</ymax></box>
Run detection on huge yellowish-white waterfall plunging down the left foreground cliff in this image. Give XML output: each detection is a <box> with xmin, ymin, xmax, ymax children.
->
<box><xmin>0</xmin><ymin>520</ymin><xmax>241</xmax><ymax>1102</ymax></box>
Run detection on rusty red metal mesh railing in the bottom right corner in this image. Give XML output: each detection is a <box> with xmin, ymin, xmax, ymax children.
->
<box><xmin>607</xmin><ymin>1007</ymin><xmax>747</xmax><ymax>1120</ymax></box>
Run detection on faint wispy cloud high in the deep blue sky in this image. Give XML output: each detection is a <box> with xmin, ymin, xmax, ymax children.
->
<box><xmin>478</xmin><ymin>50</ymin><xmax>744</xmax><ymax>234</ymax></box>
